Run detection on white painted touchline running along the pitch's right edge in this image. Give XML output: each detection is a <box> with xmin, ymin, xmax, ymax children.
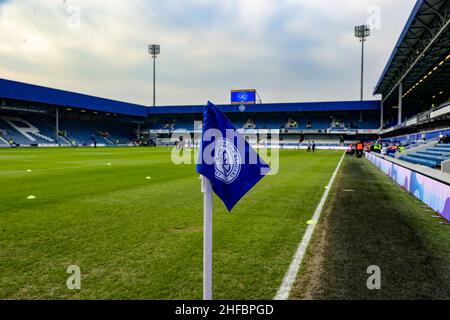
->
<box><xmin>274</xmin><ymin>153</ymin><xmax>345</xmax><ymax>300</ymax></box>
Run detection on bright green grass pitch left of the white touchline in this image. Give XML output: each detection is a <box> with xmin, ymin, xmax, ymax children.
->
<box><xmin>0</xmin><ymin>148</ymin><xmax>342</xmax><ymax>299</ymax></box>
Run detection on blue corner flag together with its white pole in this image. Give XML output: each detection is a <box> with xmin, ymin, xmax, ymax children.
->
<box><xmin>197</xmin><ymin>102</ymin><xmax>270</xmax><ymax>300</ymax></box>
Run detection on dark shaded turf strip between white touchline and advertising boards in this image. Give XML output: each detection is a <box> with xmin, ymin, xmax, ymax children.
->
<box><xmin>291</xmin><ymin>158</ymin><xmax>450</xmax><ymax>299</ymax></box>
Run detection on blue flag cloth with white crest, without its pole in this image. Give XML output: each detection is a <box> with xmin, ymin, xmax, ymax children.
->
<box><xmin>197</xmin><ymin>102</ymin><xmax>270</xmax><ymax>212</ymax></box>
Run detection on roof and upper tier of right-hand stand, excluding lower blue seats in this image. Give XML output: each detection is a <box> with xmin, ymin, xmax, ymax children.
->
<box><xmin>374</xmin><ymin>0</ymin><xmax>450</xmax><ymax>131</ymax></box>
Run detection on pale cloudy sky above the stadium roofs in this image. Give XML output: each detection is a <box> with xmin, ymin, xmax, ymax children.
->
<box><xmin>0</xmin><ymin>0</ymin><xmax>415</xmax><ymax>105</ymax></box>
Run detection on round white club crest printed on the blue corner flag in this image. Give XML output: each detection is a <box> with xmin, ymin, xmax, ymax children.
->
<box><xmin>214</xmin><ymin>139</ymin><xmax>241</xmax><ymax>184</ymax></box>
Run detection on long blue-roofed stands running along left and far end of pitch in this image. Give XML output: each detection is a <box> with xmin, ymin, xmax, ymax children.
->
<box><xmin>0</xmin><ymin>79</ymin><xmax>381</xmax><ymax>147</ymax></box>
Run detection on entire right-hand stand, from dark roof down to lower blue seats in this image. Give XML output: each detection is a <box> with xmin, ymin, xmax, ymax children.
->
<box><xmin>374</xmin><ymin>0</ymin><xmax>450</xmax><ymax>174</ymax></box>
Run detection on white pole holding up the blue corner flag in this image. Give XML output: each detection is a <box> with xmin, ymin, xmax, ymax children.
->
<box><xmin>200</xmin><ymin>176</ymin><xmax>212</xmax><ymax>300</ymax></box>
